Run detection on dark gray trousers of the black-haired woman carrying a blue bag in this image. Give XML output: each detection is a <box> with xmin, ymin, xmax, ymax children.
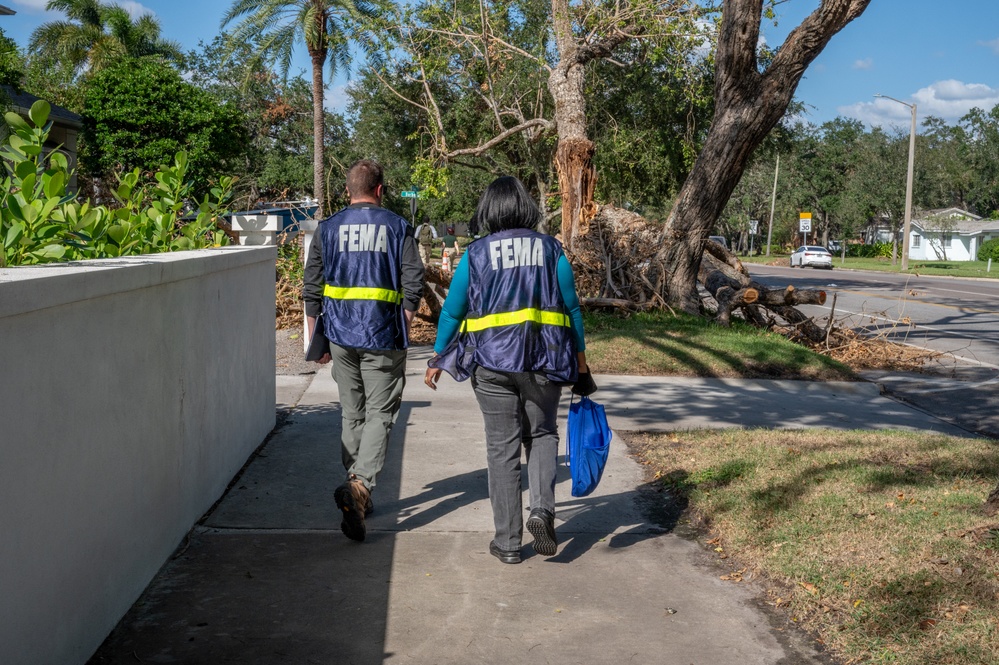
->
<box><xmin>472</xmin><ymin>367</ymin><xmax>562</xmax><ymax>550</ymax></box>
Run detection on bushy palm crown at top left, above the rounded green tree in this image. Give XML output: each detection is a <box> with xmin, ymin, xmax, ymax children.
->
<box><xmin>28</xmin><ymin>0</ymin><xmax>181</xmax><ymax>75</ymax></box>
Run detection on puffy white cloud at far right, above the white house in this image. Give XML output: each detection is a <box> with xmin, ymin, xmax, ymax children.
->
<box><xmin>837</xmin><ymin>79</ymin><xmax>999</xmax><ymax>127</ymax></box>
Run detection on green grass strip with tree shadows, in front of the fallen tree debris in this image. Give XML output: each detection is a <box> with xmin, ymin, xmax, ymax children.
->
<box><xmin>583</xmin><ymin>312</ymin><xmax>854</xmax><ymax>381</ymax></box>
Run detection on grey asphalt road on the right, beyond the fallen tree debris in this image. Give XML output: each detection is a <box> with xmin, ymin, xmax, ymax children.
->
<box><xmin>745</xmin><ymin>264</ymin><xmax>999</xmax><ymax>439</ymax></box>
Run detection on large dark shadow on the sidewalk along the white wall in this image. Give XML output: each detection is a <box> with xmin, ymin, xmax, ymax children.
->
<box><xmin>88</xmin><ymin>401</ymin><xmax>422</xmax><ymax>665</ymax></box>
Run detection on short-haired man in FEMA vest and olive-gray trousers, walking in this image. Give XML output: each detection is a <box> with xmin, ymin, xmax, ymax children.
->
<box><xmin>303</xmin><ymin>159</ymin><xmax>423</xmax><ymax>541</ymax></box>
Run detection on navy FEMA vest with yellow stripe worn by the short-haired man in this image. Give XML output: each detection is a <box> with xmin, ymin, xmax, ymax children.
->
<box><xmin>319</xmin><ymin>205</ymin><xmax>412</xmax><ymax>350</ymax></box>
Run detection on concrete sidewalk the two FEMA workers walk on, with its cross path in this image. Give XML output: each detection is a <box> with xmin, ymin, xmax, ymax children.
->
<box><xmin>91</xmin><ymin>348</ymin><xmax>966</xmax><ymax>665</ymax></box>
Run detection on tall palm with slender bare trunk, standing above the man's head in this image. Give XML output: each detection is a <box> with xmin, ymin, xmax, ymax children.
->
<box><xmin>222</xmin><ymin>0</ymin><xmax>379</xmax><ymax>218</ymax></box>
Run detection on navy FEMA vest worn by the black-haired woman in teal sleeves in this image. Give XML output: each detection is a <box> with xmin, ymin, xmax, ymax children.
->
<box><xmin>461</xmin><ymin>229</ymin><xmax>578</xmax><ymax>383</ymax></box>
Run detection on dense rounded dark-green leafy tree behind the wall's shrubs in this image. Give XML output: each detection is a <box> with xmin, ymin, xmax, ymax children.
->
<box><xmin>80</xmin><ymin>60</ymin><xmax>248</xmax><ymax>194</ymax></box>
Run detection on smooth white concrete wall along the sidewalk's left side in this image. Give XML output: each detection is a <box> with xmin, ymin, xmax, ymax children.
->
<box><xmin>0</xmin><ymin>247</ymin><xmax>275</xmax><ymax>665</ymax></box>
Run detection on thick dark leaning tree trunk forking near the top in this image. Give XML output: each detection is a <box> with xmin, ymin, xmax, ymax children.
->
<box><xmin>658</xmin><ymin>0</ymin><xmax>871</xmax><ymax>313</ymax></box>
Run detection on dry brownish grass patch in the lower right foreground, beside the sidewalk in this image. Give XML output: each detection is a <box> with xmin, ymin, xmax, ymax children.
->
<box><xmin>628</xmin><ymin>430</ymin><xmax>999</xmax><ymax>665</ymax></box>
